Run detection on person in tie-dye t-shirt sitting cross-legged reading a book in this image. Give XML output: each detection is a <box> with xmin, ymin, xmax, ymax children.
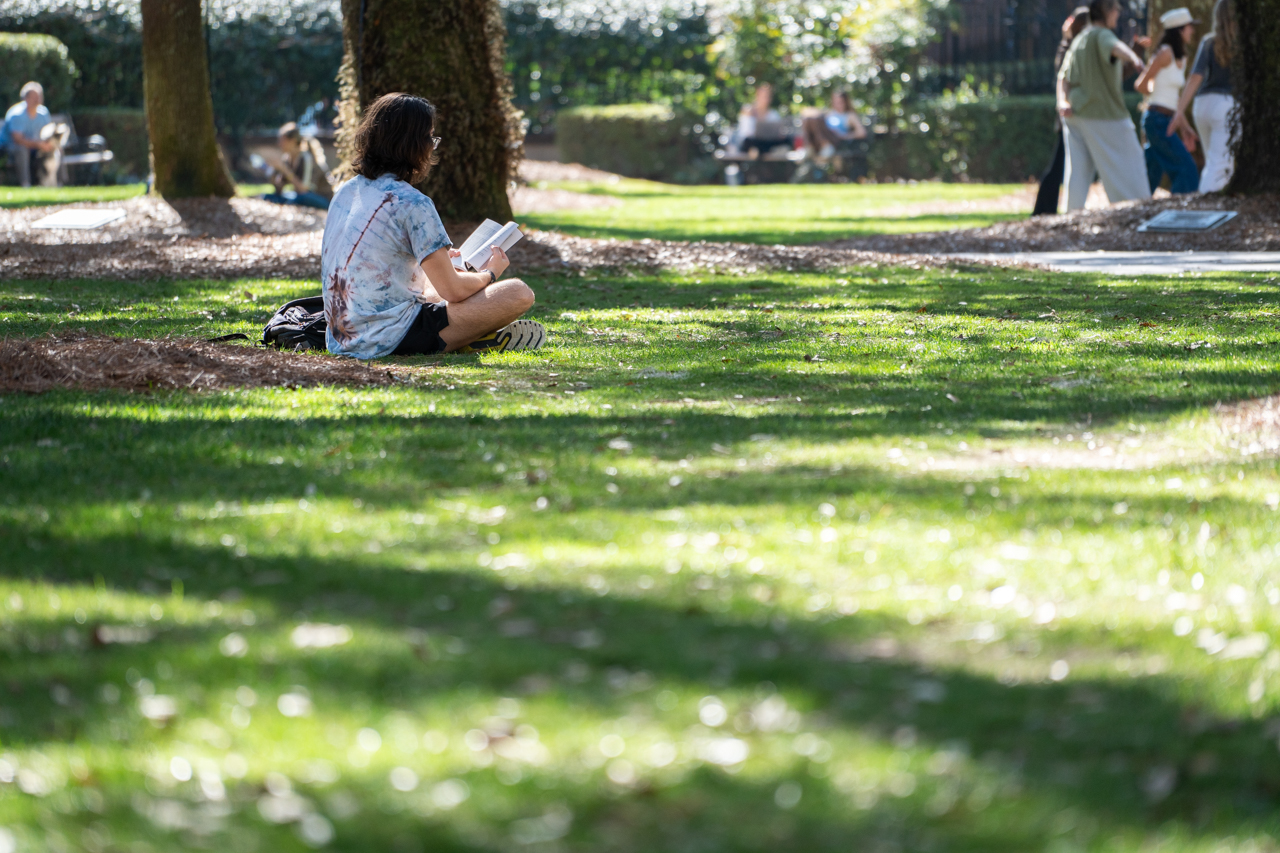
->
<box><xmin>320</xmin><ymin>92</ymin><xmax>547</xmax><ymax>359</ymax></box>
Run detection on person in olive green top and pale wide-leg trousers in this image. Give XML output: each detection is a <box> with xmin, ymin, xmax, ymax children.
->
<box><xmin>1057</xmin><ymin>0</ymin><xmax>1151</xmax><ymax>210</ymax></box>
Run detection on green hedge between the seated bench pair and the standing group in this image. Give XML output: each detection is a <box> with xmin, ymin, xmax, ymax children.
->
<box><xmin>868</xmin><ymin>93</ymin><xmax>1138</xmax><ymax>183</ymax></box>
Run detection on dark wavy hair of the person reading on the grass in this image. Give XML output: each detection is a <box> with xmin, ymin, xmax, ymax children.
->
<box><xmin>351</xmin><ymin>92</ymin><xmax>438</xmax><ymax>183</ymax></box>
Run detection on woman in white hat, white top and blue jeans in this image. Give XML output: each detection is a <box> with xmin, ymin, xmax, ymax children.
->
<box><xmin>1133</xmin><ymin>6</ymin><xmax>1199</xmax><ymax>195</ymax></box>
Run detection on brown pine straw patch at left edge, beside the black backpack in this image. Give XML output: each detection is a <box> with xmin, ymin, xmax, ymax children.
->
<box><xmin>0</xmin><ymin>334</ymin><xmax>397</xmax><ymax>393</ymax></box>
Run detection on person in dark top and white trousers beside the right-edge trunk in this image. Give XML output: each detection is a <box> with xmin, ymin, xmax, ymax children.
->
<box><xmin>1166</xmin><ymin>0</ymin><xmax>1238</xmax><ymax>192</ymax></box>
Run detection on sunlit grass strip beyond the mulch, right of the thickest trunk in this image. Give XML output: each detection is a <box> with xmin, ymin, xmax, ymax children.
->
<box><xmin>520</xmin><ymin>181</ymin><xmax>1030</xmax><ymax>245</ymax></box>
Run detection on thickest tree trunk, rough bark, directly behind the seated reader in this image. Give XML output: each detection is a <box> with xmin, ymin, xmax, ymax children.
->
<box><xmin>338</xmin><ymin>0</ymin><xmax>522</xmax><ymax>222</ymax></box>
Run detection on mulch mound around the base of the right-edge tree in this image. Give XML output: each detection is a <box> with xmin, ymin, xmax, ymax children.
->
<box><xmin>828</xmin><ymin>193</ymin><xmax>1280</xmax><ymax>255</ymax></box>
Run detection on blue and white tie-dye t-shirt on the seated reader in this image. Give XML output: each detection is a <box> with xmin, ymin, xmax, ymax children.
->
<box><xmin>320</xmin><ymin>174</ymin><xmax>453</xmax><ymax>359</ymax></box>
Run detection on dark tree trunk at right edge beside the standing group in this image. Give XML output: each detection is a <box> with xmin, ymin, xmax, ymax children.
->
<box><xmin>1228</xmin><ymin>0</ymin><xmax>1280</xmax><ymax>192</ymax></box>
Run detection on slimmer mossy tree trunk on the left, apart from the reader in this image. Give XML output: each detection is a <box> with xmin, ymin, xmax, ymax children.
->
<box><xmin>142</xmin><ymin>0</ymin><xmax>236</xmax><ymax>199</ymax></box>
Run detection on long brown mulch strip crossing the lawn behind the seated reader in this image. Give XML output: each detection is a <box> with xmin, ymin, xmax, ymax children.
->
<box><xmin>0</xmin><ymin>178</ymin><xmax>1280</xmax><ymax>280</ymax></box>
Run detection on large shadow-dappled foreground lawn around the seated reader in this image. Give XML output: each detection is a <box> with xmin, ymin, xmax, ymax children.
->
<box><xmin>0</xmin><ymin>262</ymin><xmax>1280</xmax><ymax>853</ymax></box>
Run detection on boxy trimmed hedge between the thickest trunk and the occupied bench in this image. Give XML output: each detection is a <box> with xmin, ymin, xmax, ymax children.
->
<box><xmin>556</xmin><ymin>104</ymin><xmax>696</xmax><ymax>182</ymax></box>
